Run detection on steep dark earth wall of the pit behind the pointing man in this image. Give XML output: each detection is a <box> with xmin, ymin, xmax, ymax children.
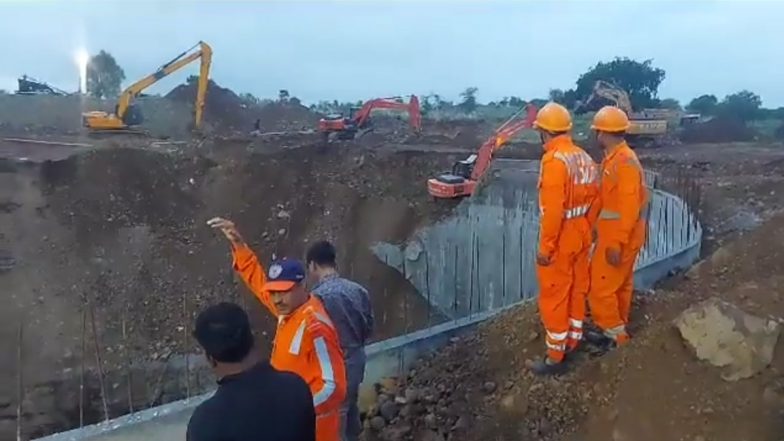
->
<box><xmin>0</xmin><ymin>145</ymin><xmax>454</xmax><ymax>439</ymax></box>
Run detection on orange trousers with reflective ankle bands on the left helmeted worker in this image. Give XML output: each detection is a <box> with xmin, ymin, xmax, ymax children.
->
<box><xmin>536</xmin><ymin>218</ymin><xmax>591</xmax><ymax>361</ymax></box>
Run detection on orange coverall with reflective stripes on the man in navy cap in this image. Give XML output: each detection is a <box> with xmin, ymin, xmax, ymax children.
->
<box><xmin>232</xmin><ymin>247</ymin><xmax>346</xmax><ymax>441</ymax></box>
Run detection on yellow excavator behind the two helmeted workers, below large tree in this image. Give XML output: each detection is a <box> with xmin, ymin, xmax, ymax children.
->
<box><xmin>580</xmin><ymin>80</ymin><xmax>668</xmax><ymax>145</ymax></box>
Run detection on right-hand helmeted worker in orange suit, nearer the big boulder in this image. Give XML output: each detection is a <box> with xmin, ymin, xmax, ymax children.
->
<box><xmin>585</xmin><ymin>106</ymin><xmax>648</xmax><ymax>347</ymax></box>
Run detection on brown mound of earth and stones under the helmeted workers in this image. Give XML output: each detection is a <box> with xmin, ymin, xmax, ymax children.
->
<box><xmin>366</xmin><ymin>210</ymin><xmax>784</xmax><ymax>441</ymax></box>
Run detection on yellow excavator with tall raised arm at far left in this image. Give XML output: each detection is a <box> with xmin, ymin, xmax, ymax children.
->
<box><xmin>82</xmin><ymin>41</ymin><xmax>212</xmax><ymax>132</ymax></box>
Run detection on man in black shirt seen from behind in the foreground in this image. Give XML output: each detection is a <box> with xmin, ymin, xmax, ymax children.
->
<box><xmin>186</xmin><ymin>303</ymin><xmax>316</xmax><ymax>441</ymax></box>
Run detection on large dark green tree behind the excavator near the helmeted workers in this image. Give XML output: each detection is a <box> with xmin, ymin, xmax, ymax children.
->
<box><xmin>575</xmin><ymin>57</ymin><xmax>665</xmax><ymax>109</ymax></box>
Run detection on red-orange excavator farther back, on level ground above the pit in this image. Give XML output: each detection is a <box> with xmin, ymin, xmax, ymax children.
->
<box><xmin>318</xmin><ymin>95</ymin><xmax>422</xmax><ymax>140</ymax></box>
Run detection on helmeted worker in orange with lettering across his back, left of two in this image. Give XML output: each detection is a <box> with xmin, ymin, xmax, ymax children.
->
<box><xmin>531</xmin><ymin>103</ymin><xmax>598</xmax><ymax>375</ymax></box>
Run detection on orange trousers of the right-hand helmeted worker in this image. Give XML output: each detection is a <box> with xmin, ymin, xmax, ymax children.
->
<box><xmin>588</xmin><ymin>220</ymin><xmax>647</xmax><ymax>338</ymax></box>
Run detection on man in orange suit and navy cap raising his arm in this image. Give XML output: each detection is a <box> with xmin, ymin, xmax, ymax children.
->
<box><xmin>208</xmin><ymin>218</ymin><xmax>346</xmax><ymax>441</ymax></box>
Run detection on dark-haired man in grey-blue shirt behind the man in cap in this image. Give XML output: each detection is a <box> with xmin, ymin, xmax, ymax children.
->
<box><xmin>306</xmin><ymin>241</ymin><xmax>373</xmax><ymax>441</ymax></box>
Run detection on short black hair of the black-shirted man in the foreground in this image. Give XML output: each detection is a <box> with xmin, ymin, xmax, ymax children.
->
<box><xmin>193</xmin><ymin>302</ymin><xmax>253</xmax><ymax>363</ymax></box>
